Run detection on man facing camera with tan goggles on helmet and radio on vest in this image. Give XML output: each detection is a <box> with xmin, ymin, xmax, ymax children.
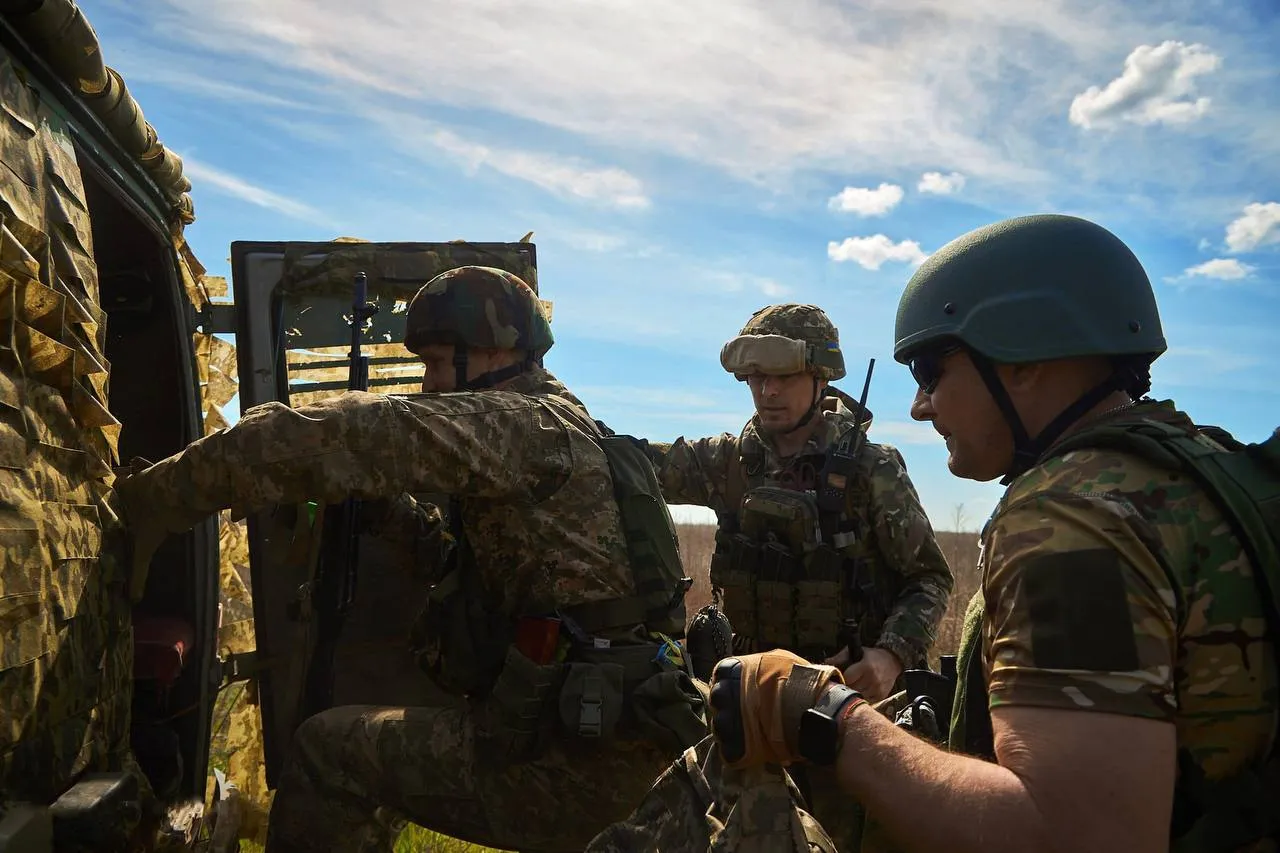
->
<box><xmin>650</xmin><ymin>305</ymin><xmax>952</xmax><ymax>699</ymax></box>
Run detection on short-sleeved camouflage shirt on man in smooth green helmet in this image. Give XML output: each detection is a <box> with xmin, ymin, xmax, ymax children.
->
<box><xmin>979</xmin><ymin>401</ymin><xmax>1277</xmax><ymax>780</ymax></box>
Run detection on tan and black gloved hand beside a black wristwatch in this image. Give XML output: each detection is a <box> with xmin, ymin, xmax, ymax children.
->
<box><xmin>710</xmin><ymin>649</ymin><xmax>845</xmax><ymax>767</ymax></box>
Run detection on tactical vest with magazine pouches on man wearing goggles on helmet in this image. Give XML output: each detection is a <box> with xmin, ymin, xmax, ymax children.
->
<box><xmin>710</xmin><ymin>427</ymin><xmax>901</xmax><ymax>661</ymax></box>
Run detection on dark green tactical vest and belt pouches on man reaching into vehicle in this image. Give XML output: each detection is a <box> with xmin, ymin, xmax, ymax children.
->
<box><xmin>413</xmin><ymin>405</ymin><xmax>705</xmax><ymax>758</ymax></box>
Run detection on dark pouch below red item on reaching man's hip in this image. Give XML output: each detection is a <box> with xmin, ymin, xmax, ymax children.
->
<box><xmin>477</xmin><ymin>644</ymin><xmax>564</xmax><ymax>766</ymax></box>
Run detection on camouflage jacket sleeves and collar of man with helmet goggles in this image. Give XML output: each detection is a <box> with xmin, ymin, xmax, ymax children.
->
<box><xmin>650</xmin><ymin>398</ymin><xmax>954</xmax><ymax>667</ymax></box>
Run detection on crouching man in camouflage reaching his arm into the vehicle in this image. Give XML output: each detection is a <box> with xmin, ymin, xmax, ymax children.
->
<box><xmin>116</xmin><ymin>266</ymin><xmax>705</xmax><ymax>852</ymax></box>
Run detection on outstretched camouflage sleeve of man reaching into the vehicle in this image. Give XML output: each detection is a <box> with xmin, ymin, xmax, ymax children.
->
<box><xmin>131</xmin><ymin>391</ymin><xmax>572</xmax><ymax>515</ymax></box>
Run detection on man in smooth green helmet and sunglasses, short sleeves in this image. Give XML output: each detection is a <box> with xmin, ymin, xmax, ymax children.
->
<box><xmin>712</xmin><ymin>215</ymin><xmax>1280</xmax><ymax>853</ymax></box>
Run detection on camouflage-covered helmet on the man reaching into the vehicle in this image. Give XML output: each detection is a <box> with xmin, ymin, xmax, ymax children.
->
<box><xmin>404</xmin><ymin>266</ymin><xmax>554</xmax><ymax>359</ymax></box>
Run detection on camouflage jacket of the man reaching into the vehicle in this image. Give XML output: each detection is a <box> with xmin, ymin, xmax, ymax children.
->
<box><xmin>120</xmin><ymin>369</ymin><xmax>635</xmax><ymax>616</ymax></box>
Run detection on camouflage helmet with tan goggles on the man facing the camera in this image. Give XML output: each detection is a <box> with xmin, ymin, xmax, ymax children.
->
<box><xmin>721</xmin><ymin>302</ymin><xmax>845</xmax><ymax>382</ymax></box>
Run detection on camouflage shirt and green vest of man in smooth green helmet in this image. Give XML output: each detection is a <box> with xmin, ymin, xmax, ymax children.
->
<box><xmin>951</xmin><ymin>401</ymin><xmax>1280</xmax><ymax>853</ymax></box>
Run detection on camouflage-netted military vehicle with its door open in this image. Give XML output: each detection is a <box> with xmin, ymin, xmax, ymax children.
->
<box><xmin>0</xmin><ymin>0</ymin><xmax>536</xmax><ymax>850</ymax></box>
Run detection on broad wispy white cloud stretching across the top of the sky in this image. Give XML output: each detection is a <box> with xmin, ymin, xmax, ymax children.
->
<box><xmin>140</xmin><ymin>0</ymin><xmax>1128</xmax><ymax>181</ymax></box>
